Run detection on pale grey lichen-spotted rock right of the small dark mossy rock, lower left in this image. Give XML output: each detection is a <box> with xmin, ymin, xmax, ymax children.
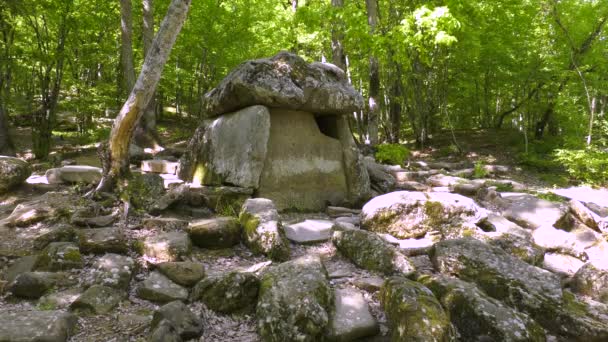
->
<box><xmin>85</xmin><ymin>253</ymin><xmax>136</xmax><ymax>291</ymax></box>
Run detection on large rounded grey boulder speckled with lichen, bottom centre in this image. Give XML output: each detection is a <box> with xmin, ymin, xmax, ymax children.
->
<box><xmin>256</xmin><ymin>256</ymin><xmax>333</xmax><ymax>341</ymax></box>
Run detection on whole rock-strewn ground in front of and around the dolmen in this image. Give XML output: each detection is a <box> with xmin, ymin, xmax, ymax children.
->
<box><xmin>0</xmin><ymin>150</ymin><xmax>608</xmax><ymax>341</ymax></box>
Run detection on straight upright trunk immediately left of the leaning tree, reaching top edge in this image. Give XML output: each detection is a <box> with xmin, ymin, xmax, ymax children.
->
<box><xmin>120</xmin><ymin>0</ymin><xmax>135</xmax><ymax>93</ymax></box>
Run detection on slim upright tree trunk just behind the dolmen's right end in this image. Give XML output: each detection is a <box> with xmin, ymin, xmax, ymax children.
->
<box><xmin>365</xmin><ymin>0</ymin><xmax>380</xmax><ymax>145</ymax></box>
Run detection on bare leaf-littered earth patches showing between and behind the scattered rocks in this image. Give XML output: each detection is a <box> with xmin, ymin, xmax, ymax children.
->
<box><xmin>0</xmin><ymin>121</ymin><xmax>604</xmax><ymax>342</ymax></box>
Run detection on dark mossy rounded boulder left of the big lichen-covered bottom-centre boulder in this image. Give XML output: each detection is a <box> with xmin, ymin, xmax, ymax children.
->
<box><xmin>191</xmin><ymin>272</ymin><xmax>260</xmax><ymax>314</ymax></box>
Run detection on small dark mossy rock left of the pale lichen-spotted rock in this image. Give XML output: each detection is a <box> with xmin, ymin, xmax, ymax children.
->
<box><xmin>37</xmin><ymin>242</ymin><xmax>84</xmax><ymax>271</ymax></box>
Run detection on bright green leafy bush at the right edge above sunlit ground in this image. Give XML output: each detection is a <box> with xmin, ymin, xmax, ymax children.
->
<box><xmin>555</xmin><ymin>148</ymin><xmax>608</xmax><ymax>186</ymax></box>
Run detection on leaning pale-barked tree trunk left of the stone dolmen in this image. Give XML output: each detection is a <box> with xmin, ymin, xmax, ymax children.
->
<box><xmin>96</xmin><ymin>0</ymin><xmax>191</xmax><ymax>191</ymax></box>
